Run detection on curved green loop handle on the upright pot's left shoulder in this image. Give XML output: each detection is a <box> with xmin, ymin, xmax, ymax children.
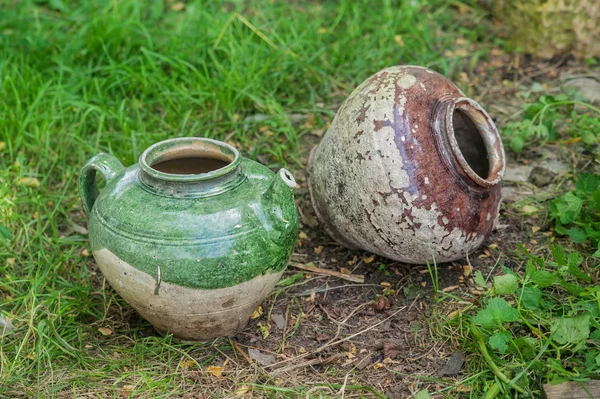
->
<box><xmin>79</xmin><ymin>152</ymin><xmax>124</xmax><ymax>215</ymax></box>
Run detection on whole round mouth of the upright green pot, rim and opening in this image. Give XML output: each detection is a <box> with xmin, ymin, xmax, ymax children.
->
<box><xmin>139</xmin><ymin>137</ymin><xmax>240</xmax><ymax>182</ymax></box>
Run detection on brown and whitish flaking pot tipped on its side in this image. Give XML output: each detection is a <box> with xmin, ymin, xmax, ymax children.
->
<box><xmin>309</xmin><ymin>66</ymin><xmax>505</xmax><ymax>264</ymax></box>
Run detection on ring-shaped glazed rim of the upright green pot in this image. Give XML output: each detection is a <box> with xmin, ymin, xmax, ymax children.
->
<box><xmin>138</xmin><ymin>137</ymin><xmax>241</xmax><ymax>183</ymax></box>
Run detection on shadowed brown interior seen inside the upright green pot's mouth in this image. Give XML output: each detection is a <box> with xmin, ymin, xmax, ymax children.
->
<box><xmin>150</xmin><ymin>142</ymin><xmax>234</xmax><ymax>175</ymax></box>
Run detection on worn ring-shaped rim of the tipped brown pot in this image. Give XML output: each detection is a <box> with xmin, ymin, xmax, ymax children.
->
<box><xmin>444</xmin><ymin>97</ymin><xmax>506</xmax><ymax>187</ymax></box>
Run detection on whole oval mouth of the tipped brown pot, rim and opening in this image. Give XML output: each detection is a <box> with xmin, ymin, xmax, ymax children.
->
<box><xmin>447</xmin><ymin>97</ymin><xmax>505</xmax><ymax>187</ymax></box>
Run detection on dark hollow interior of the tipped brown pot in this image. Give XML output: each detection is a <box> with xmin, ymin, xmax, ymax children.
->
<box><xmin>452</xmin><ymin>109</ymin><xmax>490</xmax><ymax>179</ymax></box>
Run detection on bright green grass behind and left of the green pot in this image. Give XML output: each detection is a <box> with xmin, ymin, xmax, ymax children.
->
<box><xmin>0</xmin><ymin>0</ymin><xmax>502</xmax><ymax>398</ymax></box>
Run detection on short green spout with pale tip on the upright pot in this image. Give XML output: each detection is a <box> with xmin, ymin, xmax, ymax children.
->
<box><xmin>262</xmin><ymin>168</ymin><xmax>296</xmax><ymax>229</ymax></box>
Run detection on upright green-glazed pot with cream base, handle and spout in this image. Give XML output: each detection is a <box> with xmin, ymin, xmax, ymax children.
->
<box><xmin>79</xmin><ymin>138</ymin><xmax>298</xmax><ymax>341</ymax></box>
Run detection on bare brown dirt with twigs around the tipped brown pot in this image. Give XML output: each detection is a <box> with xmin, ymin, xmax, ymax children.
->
<box><xmin>90</xmin><ymin>53</ymin><xmax>593</xmax><ymax>398</ymax></box>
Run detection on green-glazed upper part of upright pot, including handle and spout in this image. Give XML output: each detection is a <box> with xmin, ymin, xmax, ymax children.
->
<box><xmin>80</xmin><ymin>138</ymin><xmax>298</xmax><ymax>289</ymax></box>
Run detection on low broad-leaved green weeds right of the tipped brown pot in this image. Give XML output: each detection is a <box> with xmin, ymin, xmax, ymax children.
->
<box><xmin>422</xmin><ymin>95</ymin><xmax>600</xmax><ymax>399</ymax></box>
